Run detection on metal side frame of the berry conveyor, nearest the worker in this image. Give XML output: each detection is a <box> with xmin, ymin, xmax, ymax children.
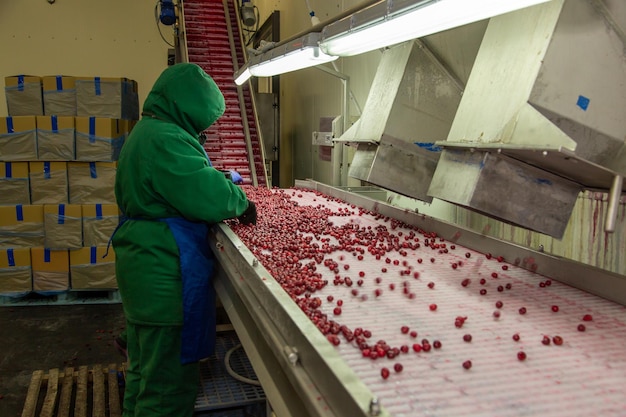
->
<box><xmin>209</xmin><ymin>224</ymin><xmax>389</xmax><ymax>417</ymax></box>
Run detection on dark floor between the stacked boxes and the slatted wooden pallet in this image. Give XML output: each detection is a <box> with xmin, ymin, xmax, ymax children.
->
<box><xmin>0</xmin><ymin>303</ymin><xmax>124</xmax><ymax>417</ymax></box>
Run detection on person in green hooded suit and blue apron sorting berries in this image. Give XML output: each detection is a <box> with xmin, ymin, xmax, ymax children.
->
<box><xmin>112</xmin><ymin>63</ymin><xmax>256</xmax><ymax>417</ymax></box>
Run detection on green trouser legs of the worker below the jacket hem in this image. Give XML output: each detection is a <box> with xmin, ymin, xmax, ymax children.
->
<box><xmin>124</xmin><ymin>322</ymin><xmax>199</xmax><ymax>417</ymax></box>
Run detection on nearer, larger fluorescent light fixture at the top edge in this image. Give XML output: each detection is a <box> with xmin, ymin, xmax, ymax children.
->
<box><xmin>320</xmin><ymin>0</ymin><xmax>549</xmax><ymax>56</ymax></box>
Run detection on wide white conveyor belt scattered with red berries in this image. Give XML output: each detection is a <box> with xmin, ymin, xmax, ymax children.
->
<box><xmin>217</xmin><ymin>184</ymin><xmax>626</xmax><ymax>417</ymax></box>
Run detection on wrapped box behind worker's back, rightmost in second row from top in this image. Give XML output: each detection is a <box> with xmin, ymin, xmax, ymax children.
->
<box><xmin>76</xmin><ymin>117</ymin><xmax>125</xmax><ymax>161</ymax></box>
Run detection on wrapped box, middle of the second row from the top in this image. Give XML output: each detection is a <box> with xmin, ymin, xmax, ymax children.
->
<box><xmin>37</xmin><ymin>116</ymin><xmax>76</xmax><ymax>161</ymax></box>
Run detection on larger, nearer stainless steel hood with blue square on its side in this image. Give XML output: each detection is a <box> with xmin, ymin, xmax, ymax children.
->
<box><xmin>428</xmin><ymin>0</ymin><xmax>626</xmax><ymax>238</ymax></box>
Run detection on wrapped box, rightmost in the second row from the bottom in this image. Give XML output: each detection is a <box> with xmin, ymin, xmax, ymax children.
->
<box><xmin>82</xmin><ymin>204</ymin><xmax>120</xmax><ymax>246</ymax></box>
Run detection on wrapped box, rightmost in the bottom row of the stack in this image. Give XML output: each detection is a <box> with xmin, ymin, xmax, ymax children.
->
<box><xmin>70</xmin><ymin>246</ymin><xmax>117</xmax><ymax>290</ymax></box>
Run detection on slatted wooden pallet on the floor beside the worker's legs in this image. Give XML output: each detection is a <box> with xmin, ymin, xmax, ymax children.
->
<box><xmin>22</xmin><ymin>364</ymin><xmax>124</xmax><ymax>417</ymax></box>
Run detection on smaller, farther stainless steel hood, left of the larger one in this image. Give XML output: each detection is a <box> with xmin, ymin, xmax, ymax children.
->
<box><xmin>338</xmin><ymin>41</ymin><xmax>462</xmax><ymax>202</ymax></box>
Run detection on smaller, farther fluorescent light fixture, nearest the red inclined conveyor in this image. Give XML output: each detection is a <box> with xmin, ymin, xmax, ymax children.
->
<box><xmin>235</xmin><ymin>32</ymin><xmax>339</xmax><ymax>85</ymax></box>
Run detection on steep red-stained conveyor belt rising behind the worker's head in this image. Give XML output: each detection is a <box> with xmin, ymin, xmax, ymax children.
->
<box><xmin>182</xmin><ymin>0</ymin><xmax>266</xmax><ymax>187</ymax></box>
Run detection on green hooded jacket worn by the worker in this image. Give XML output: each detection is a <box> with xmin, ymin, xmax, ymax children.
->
<box><xmin>113</xmin><ymin>63</ymin><xmax>248</xmax><ymax>326</ymax></box>
